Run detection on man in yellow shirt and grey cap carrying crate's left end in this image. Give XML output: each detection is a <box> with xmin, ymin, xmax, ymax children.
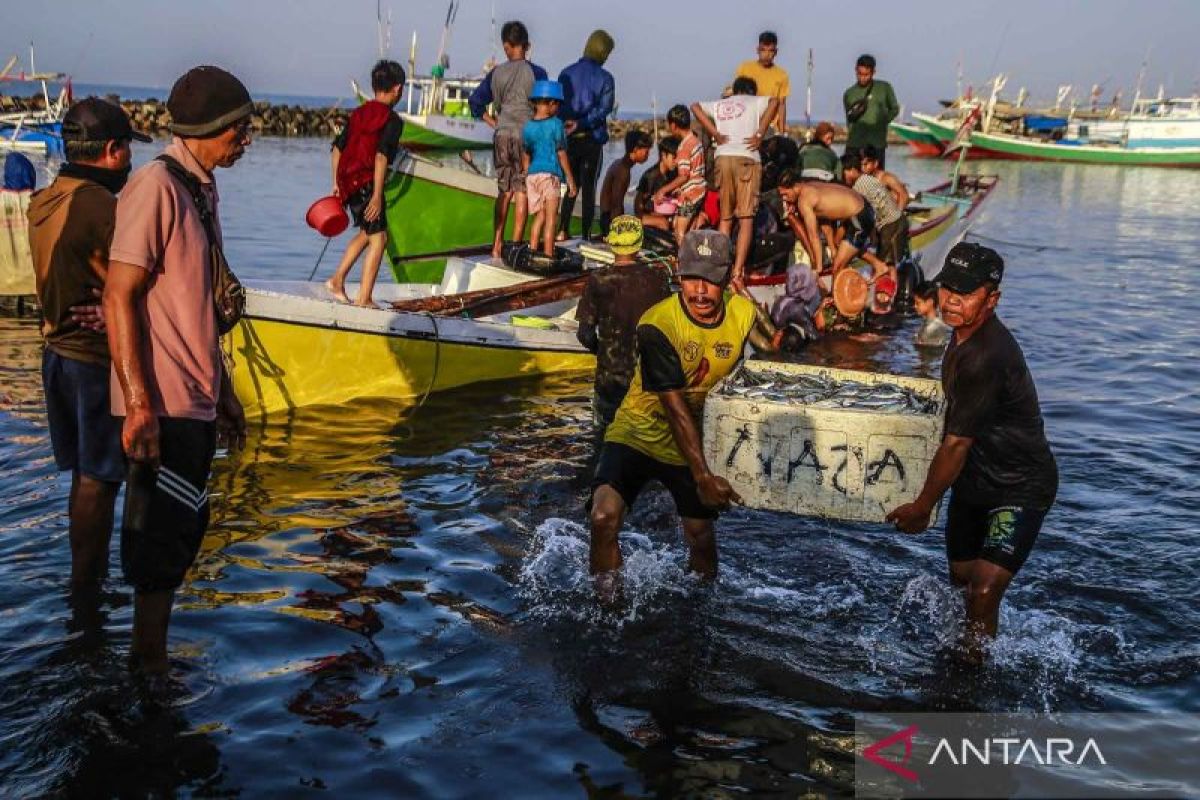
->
<box><xmin>588</xmin><ymin>230</ymin><xmax>781</xmax><ymax>588</ymax></box>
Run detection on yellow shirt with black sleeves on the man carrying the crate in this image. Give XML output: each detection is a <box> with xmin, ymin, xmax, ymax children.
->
<box><xmin>605</xmin><ymin>291</ymin><xmax>755</xmax><ymax>465</ymax></box>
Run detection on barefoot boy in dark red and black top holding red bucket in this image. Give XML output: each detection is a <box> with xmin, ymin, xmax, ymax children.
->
<box><xmin>325</xmin><ymin>61</ymin><xmax>404</xmax><ymax>307</ymax></box>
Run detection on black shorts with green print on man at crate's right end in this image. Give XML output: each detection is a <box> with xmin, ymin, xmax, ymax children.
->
<box><xmin>946</xmin><ymin>494</ymin><xmax>1049</xmax><ymax>575</ymax></box>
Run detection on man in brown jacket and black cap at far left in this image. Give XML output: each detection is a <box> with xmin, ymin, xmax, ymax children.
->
<box><xmin>29</xmin><ymin>97</ymin><xmax>150</xmax><ymax>589</ymax></box>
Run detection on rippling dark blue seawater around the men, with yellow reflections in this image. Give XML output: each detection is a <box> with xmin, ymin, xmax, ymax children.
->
<box><xmin>0</xmin><ymin>148</ymin><xmax>1200</xmax><ymax>798</ymax></box>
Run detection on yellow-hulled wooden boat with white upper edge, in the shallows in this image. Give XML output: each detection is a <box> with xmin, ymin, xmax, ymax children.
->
<box><xmin>224</xmin><ymin>257</ymin><xmax>595</xmax><ymax>415</ymax></box>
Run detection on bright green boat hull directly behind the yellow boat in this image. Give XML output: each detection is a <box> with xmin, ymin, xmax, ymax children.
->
<box><xmin>384</xmin><ymin>158</ymin><xmax>580</xmax><ymax>283</ymax></box>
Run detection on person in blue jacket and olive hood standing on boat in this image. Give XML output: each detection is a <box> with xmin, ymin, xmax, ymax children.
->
<box><xmin>558</xmin><ymin>30</ymin><xmax>616</xmax><ymax>239</ymax></box>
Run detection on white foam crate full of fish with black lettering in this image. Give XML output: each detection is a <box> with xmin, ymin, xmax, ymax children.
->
<box><xmin>704</xmin><ymin>361</ymin><xmax>944</xmax><ymax>524</ymax></box>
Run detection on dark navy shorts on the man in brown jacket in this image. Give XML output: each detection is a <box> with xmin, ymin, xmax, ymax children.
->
<box><xmin>42</xmin><ymin>349</ymin><xmax>125</xmax><ymax>483</ymax></box>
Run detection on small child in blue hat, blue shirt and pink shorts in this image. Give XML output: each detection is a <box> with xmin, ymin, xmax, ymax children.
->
<box><xmin>521</xmin><ymin>80</ymin><xmax>576</xmax><ymax>257</ymax></box>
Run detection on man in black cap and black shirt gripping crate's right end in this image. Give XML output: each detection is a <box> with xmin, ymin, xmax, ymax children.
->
<box><xmin>887</xmin><ymin>242</ymin><xmax>1058</xmax><ymax>662</ymax></box>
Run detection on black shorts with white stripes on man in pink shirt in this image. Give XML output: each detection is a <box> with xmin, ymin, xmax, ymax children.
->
<box><xmin>121</xmin><ymin>417</ymin><xmax>217</xmax><ymax>593</ymax></box>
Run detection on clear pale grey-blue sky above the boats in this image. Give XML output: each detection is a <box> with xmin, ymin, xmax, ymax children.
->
<box><xmin>0</xmin><ymin>0</ymin><xmax>1200</xmax><ymax>119</ymax></box>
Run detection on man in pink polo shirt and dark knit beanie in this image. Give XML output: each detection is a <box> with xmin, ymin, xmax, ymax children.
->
<box><xmin>104</xmin><ymin>67</ymin><xmax>253</xmax><ymax>673</ymax></box>
